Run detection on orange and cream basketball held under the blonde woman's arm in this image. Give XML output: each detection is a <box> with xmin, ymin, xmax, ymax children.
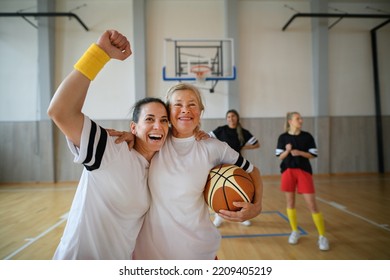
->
<box><xmin>204</xmin><ymin>164</ymin><xmax>255</xmax><ymax>212</ymax></box>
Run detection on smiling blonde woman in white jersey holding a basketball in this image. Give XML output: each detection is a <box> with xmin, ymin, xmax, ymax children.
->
<box><xmin>134</xmin><ymin>84</ymin><xmax>263</xmax><ymax>260</ymax></box>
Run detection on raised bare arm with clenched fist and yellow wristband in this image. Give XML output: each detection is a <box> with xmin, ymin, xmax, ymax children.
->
<box><xmin>47</xmin><ymin>30</ymin><xmax>131</xmax><ymax>146</ymax></box>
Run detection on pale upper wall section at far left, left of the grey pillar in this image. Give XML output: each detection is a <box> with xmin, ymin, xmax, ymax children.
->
<box><xmin>0</xmin><ymin>0</ymin><xmax>39</xmax><ymax>121</ymax></box>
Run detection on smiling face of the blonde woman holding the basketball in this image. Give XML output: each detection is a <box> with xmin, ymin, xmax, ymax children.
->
<box><xmin>169</xmin><ymin>89</ymin><xmax>202</xmax><ymax>138</ymax></box>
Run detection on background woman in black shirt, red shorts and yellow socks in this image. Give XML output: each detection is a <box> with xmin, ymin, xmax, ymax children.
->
<box><xmin>276</xmin><ymin>112</ymin><xmax>329</xmax><ymax>251</ymax></box>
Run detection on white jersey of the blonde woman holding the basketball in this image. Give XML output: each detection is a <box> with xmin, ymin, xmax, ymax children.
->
<box><xmin>134</xmin><ymin>136</ymin><xmax>253</xmax><ymax>260</ymax></box>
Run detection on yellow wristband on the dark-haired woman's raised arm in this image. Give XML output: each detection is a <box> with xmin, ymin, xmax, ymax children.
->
<box><xmin>74</xmin><ymin>44</ymin><xmax>110</xmax><ymax>81</ymax></box>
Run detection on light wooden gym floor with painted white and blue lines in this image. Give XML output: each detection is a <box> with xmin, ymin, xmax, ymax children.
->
<box><xmin>0</xmin><ymin>175</ymin><xmax>390</xmax><ymax>260</ymax></box>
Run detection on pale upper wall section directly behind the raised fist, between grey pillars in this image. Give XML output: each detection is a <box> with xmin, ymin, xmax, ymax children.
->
<box><xmin>56</xmin><ymin>0</ymin><xmax>136</xmax><ymax>119</ymax></box>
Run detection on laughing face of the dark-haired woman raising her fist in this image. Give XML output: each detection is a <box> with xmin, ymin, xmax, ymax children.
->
<box><xmin>131</xmin><ymin>102</ymin><xmax>168</xmax><ymax>160</ymax></box>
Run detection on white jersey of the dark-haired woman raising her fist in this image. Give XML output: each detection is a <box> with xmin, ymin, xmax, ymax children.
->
<box><xmin>53</xmin><ymin>116</ymin><xmax>150</xmax><ymax>260</ymax></box>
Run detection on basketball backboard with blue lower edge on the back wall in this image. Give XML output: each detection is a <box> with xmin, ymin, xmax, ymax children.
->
<box><xmin>162</xmin><ymin>38</ymin><xmax>236</xmax><ymax>86</ymax></box>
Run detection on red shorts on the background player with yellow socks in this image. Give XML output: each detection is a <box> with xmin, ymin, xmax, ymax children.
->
<box><xmin>280</xmin><ymin>168</ymin><xmax>315</xmax><ymax>194</ymax></box>
